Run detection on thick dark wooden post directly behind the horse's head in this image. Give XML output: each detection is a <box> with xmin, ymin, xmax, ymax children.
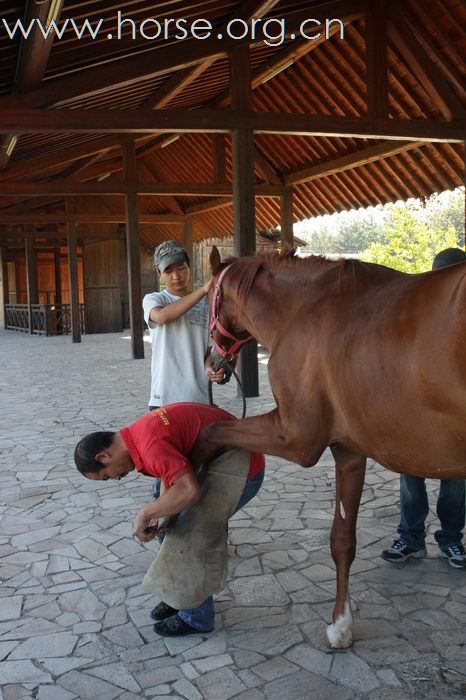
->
<box><xmin>230</xmin><ymin>46</ymin><xmax>259</xmax><ymax>396</ymax></box>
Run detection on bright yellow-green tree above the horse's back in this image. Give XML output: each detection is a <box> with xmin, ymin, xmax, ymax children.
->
<box><xmin>361</xmin><ymin>205</ymin><xmax>457</xmax><ymax>272</ymax></box>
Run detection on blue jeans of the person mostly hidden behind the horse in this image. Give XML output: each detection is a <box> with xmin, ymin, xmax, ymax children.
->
<box><xmin>398</xmin><ymin>474</ymin><xmax>465</xmax><ymax>550</ymax></box>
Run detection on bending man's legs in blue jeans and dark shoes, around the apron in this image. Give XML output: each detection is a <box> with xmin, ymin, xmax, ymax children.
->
<box><xmin>154</xmin><ymin>470</ymin><xmax>264</xmax><ymax>635</ymax></box>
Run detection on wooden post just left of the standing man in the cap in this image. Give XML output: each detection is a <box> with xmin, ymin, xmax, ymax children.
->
<box><xmin>123</xmin><ymin>141</ymin><xmax>144</xmax><ymax>360</ymax></box>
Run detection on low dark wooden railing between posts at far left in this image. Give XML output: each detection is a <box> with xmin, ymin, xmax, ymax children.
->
<box><xmin>5</xmin><ymin>304</ymin><xmax>85</xmax><ymax>335</ymax></box>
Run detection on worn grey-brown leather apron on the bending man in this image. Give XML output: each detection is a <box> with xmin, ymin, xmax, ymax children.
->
<box><xmin>142</xmin><ymin>450</ymin><xmax>250</xmax><ymax>610</ymax></box>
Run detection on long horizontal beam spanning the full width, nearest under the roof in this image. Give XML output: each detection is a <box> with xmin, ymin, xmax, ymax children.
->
<box><xmin>0</xmin><ymin>109</ymin><xmax>466</xmax><ymax>143</ymax></box>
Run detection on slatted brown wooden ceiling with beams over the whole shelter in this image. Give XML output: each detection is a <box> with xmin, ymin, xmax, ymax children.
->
<box><xmin>0</xmin><ymin>0</ymin><xmax>466</xmax><ymax>247</ymax></box>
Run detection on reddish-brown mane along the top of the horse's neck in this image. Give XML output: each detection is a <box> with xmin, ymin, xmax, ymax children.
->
<box><xmin>222</xmin><ymin>245</ymin><xmax>394</xmax><ymax>304</ymax></box>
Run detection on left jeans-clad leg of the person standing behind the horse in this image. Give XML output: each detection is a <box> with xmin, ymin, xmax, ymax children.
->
<box><xmin>398</xmin><ymin>474</ymin><xmax>429</xmax><ymax>551</ymax></box>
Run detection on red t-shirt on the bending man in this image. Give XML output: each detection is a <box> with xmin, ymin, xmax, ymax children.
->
<box><xmin>120</xmin><ymin>403</ymin><xmax>264</xmax><ymax>486</ymax></box>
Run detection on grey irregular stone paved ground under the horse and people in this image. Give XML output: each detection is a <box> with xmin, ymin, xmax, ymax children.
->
<box><xmin>0</xmin><ymin>332</ymin><xmax>466</xmax><ymax>700</ymax></box>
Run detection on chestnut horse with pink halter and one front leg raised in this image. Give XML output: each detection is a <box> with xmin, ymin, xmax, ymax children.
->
<box><xmin>197</xmin><ymin>248</ymin><xmax>466</xmax><ymax>648</ymax></box>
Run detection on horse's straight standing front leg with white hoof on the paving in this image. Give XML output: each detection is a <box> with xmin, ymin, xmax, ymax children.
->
<box><xmin>327</xmin><ymin>447</ymin><xmax>366</xmax><ymax>649</ymax></box>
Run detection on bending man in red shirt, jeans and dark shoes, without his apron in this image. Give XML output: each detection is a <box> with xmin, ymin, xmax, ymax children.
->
<box><xmin>74</xmin><ymin>403</ymin><xmax>264</xmax><ymax>636</ymax></box>
